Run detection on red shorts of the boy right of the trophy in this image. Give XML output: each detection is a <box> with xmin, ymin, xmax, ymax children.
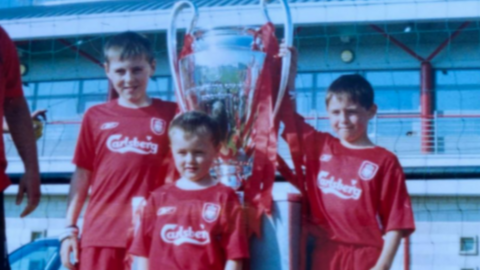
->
<box><xmin>312</xmin><ymin>241</ymin><xmax>382</xmax><ymax>270</ymax></box>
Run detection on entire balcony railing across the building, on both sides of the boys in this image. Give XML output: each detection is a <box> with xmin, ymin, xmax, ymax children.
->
<box><xmin>4</xmin><ymin>113</ymin><xmax>480</xmax><ymax>158</ymax></box>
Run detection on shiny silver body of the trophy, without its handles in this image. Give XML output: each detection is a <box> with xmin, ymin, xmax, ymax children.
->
<box><xmin>179</xmin><ymin>28</ymin><xmax>266</xmax><ymax>189</ymax></box>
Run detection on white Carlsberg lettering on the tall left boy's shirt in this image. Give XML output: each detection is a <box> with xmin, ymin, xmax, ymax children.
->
<box><xmin>107</xmin><ymin>134</ymin><xmax>158</xmax><ymax>155</ymax></box>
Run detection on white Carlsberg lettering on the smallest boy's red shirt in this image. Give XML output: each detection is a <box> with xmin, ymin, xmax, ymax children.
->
<box><xmin>160</xmin><ymin>224</ymin><xmax>210</xmax><ymax>246</ymax></box>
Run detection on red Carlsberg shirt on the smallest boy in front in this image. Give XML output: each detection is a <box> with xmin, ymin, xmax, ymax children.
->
<box><xmin>130</xmin><ymin>183</ymin><xmax>249</xmax><ymax>270</ymax></box>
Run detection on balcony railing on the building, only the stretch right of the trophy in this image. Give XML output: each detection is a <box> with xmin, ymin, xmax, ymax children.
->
<box><xmin>279</xmin><ymin>112</ymin><xmax>480</xmax><ymax>156</ymax></box>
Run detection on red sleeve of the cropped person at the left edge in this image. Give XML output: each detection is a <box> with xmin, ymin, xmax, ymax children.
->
<box><xmin>0</xmin><ymin>27</ymin><xmax>23</xmax><ymax>98</ymax></box>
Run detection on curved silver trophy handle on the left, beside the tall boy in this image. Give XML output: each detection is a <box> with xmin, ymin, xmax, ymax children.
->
<box><xmin>167</xmin><ymin>1</ymin><xmax>198</xmax><ymax>112</ymax></box>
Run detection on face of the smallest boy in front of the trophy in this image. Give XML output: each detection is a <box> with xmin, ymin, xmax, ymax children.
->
<box><xmin>170</xmin><ymin>128</ymin><xmax>218</xmax><ymax>182</ymax></box>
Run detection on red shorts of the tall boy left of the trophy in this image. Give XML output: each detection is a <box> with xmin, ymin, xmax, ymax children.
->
<box><xmin>79</xmin><ymin>247</ymin><xmax>131</xmax><ymax>270</ymax></box>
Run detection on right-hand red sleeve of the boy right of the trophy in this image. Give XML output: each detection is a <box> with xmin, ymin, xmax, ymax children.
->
<box><xmin>379</xmin><ymin>158</ymin><xmax>415</xmax><ymax>236</ymax></box>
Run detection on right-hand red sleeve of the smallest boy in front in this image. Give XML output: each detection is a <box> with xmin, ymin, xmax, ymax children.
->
<box><xmin>222</xmin><ymin>192</ymin><xmax>249</xmax><ymax>260</ymax></box>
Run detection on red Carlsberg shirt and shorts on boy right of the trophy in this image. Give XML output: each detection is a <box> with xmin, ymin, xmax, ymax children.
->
<box><xmin>285</xmin><ymin>114</ymin><xmax>415</xmax><ymax>270</ymax></box>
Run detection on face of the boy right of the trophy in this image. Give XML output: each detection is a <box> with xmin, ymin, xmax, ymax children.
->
<box><xmin>327</xmin><ymin>95</ymin><xmax>377</xmax><ymax>143</ymax></box>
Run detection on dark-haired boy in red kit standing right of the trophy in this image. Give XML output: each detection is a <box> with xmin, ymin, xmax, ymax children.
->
<box><xmin>284</xmin><ymin>71</ymin><xmax>415</xmax><ymax>270</ymax></box>
